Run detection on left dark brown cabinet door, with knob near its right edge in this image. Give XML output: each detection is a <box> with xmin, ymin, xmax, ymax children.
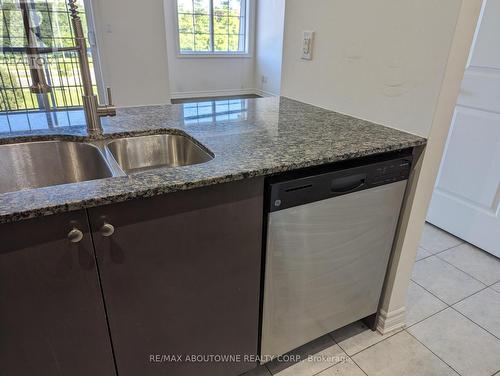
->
<box><xmin>0</xmin><ymin>212</ymin><xmax>115</xmax><ymax>376</ymax></box>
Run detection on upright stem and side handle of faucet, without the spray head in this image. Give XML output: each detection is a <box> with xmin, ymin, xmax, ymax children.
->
<box><xmin>68</xmin><ymin>0</ymin><xmax>116</xmax><ymax>136</ymax></box>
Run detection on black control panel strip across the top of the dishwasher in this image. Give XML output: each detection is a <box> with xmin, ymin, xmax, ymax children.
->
<box><xmin>267</xmin><ymin>156</ymin><xmax>412</xmax><ymax>212</ymax></box>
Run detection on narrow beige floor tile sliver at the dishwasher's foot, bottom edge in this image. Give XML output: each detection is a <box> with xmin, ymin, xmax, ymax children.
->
<box><xmin>276</xmin><ymin>345</ymin><xmax>348</xmax><ymax>376</ymax></box>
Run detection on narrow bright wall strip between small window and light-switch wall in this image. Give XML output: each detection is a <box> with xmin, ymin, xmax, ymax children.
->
<box><xmin>254</xmin><ymin>0</ymin><xmax>285</xmax><ymax>95</ymax></box>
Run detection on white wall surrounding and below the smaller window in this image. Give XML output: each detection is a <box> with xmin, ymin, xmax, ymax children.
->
<box><xmin>164</xmin><ymin>0</ymin><xmax>255</xmax><ymax>98</ymax></box>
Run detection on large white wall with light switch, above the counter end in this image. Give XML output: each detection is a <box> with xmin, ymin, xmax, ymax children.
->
<box><xmin>282</xmin><ymin>0</ymin><xmax>461</xmax><ymax>136</ymax></box>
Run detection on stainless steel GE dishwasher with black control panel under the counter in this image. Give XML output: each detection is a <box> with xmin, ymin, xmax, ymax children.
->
<box><xmin>261</xmin><ymin>155</ymin><xmax>411</xmax><ymax>356</ymax></box>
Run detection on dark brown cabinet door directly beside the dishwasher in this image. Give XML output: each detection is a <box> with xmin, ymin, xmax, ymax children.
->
<box><xmin>90</xmin><ymin>179</ymin><xmax>263</xmax><ymax>376</ymax></box>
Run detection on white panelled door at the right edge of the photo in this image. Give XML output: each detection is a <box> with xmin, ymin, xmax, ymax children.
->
<box><xmin>427</xmin><ymin>0</ymin><xmax>500</xmax><ymax>257</ymax></box>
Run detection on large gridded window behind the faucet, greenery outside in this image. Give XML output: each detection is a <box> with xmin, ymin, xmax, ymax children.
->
<box><xmin>0</xmin><ymin>0</ymin><xmax>101</xmax><ymax>113</ymax></box>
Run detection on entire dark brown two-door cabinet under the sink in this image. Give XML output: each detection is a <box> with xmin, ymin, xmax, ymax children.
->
<box><xmin>0</xmin><ymin>179</ymin><xmax>263</xmax><ymax>376</ymax></box>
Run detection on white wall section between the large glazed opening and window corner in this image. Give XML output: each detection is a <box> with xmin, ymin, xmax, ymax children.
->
<box><xmin>92</xmin><ymin>0</ymin><xmax>170</xmax><ymax>107</ymax></box>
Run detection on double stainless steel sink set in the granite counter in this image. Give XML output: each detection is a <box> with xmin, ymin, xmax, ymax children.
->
<box><xmin>0</xmin><ymin>134</ymin><xmax>214</xmax><ymax>194</ymax></box>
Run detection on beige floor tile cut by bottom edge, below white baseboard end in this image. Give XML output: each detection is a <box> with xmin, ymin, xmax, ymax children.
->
<box><xmin>353</xmin><ymin>332</ymin><xmax>457</xmax><ymax>376</ymax></box>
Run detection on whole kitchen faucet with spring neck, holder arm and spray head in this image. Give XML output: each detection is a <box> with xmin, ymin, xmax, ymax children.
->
<box><xmin>20</xmin><ymin>0</ymin><xmax>116</xmax><ymax>137</ymax></box>
